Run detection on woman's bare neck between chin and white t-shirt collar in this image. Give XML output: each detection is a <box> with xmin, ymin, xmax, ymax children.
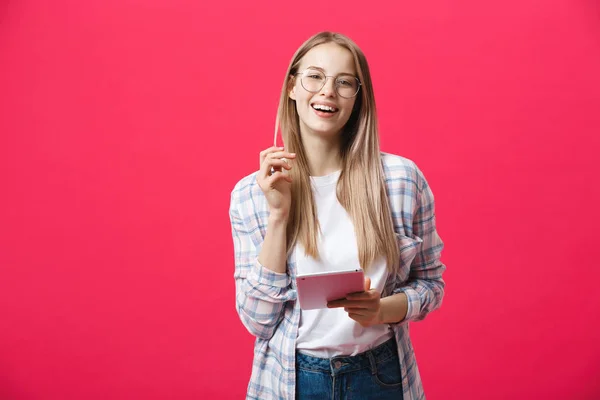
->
<box><xmin>302</xmin><ymin>135</ymin><xmax>342</xmax><ymax>176</ymax></box>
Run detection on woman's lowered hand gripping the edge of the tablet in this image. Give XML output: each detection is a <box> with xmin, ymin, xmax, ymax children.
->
<box><xmin>327</xmin><ymin>277</ymin><xmax>382</xmax><ymax>327</ymax></box>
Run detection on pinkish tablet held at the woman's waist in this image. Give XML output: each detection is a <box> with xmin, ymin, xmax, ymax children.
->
<box><xmin>296</xmin><ymin>268</ymin><xmax>365</xmax><ymax>310</ymax></box>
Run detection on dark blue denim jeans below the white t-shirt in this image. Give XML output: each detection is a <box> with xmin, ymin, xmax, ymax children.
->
<box><xmin>296</xmin><ymin>338</ymin><xmax>402</xmax><ymax>400</ymax></box>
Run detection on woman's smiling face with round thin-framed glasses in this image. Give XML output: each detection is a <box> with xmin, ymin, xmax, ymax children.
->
<box><xmin>289</xmin><ymin>43</ymin><xmax>356</xmax><ymax>141</ymax></box>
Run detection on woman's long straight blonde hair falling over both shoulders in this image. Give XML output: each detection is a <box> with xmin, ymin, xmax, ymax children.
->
<box><xmin>275</xmin><ymin>32</ymin><xmax>399</xmax><ymax>271</ymax></box>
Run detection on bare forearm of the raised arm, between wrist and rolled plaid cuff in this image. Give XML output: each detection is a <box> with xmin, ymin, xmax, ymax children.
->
<box><xmin>258</xmin><ymin>214</ymin><xmax>287</xmax><ymax>274</ymax></box>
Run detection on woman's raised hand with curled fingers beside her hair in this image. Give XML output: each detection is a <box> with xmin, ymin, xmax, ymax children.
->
<box><xmin>256</xmin><ymin>147</ymin><xmax>296</xmax><ymax>219</ymax></box>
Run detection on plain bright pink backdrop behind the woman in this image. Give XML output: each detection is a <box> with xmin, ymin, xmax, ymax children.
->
<box><xmin>0</xmin><ymin>0</ymin><xmax>600</xmax><ymax>400</ymax></box>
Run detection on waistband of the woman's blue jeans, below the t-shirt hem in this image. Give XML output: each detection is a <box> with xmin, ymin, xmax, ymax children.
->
<box><xmin>296</xmin><ymin>337</ymin><xmax>398</xmax><ymax>374</ymax></box>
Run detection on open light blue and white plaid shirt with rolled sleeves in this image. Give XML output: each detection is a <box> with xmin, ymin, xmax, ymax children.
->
<box><xmin>229</xmin><ymin>153</ymin><xmax>446</xmax><ymax>400</ymax></box>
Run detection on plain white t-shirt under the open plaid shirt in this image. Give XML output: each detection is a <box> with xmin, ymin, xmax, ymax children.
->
<box><xmin>295</xmin><ymin>171</ymin><xmax>393</xmax><ymax>358</ymax></box>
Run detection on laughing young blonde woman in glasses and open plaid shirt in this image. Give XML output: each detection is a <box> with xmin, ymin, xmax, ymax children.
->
<box><xmin>230</xmin><ymin>32</ymin><xmax>446</xmax><ymax>400</ymax></box>
